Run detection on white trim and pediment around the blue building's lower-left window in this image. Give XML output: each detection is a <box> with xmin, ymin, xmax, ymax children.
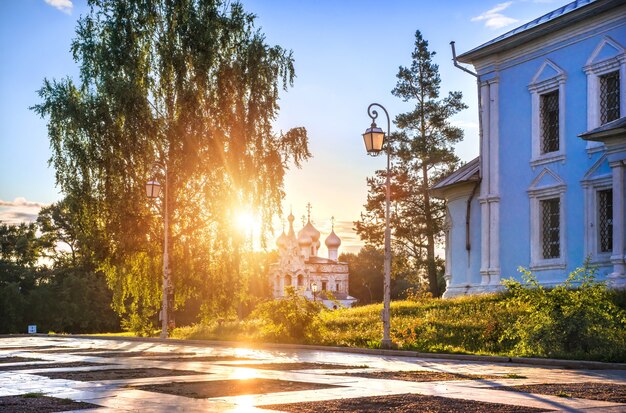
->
<box><xmin>528</xmin><ymin>169</ymin><xmax>567</xmax><ymax>271</ymax></box>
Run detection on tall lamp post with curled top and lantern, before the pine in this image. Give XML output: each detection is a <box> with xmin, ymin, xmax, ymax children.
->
<box><xmin>363</xmin><ymin>103</ymin><xmax>391</xmax><ymax>348</ymax></box>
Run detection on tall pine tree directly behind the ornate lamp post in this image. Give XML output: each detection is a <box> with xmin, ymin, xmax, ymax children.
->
<box><xmin>355</xmin><ymin>31</ymin><xmax>466</xmax><ymax>297</ymax></box>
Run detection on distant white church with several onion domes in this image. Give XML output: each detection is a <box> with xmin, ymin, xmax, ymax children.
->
<box><xmin>269</xmin><ymin>205</ymin><xmax>356</xmax><ymax>309</ymax></box>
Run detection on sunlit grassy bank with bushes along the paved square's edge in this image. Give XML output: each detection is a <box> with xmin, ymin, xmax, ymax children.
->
<box><xmin>173</xmin><ymin>286</ymin><xmax>626</xmax><ymax>362</ymax></box>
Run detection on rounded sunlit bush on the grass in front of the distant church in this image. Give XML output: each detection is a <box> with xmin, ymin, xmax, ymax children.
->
<box><xmin>250</xmin><ymin>288</ymin><xmax>323</xmax><ymax>343</ymax></box>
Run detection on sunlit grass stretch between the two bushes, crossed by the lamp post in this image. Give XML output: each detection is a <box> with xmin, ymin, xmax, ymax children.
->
<box><xmin>322</xmin><ymin>295</ymin><xmax>516</xmax><ymax>354</ymax></box>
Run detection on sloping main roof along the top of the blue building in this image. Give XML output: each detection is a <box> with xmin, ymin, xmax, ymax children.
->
<box><xmin>458</xmin><ymin>0</ymin><xmax>625</xmax><ymax>63</ymax></box>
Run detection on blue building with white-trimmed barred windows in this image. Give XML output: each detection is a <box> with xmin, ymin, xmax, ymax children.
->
<box><xmin>433</xmin><ymin>0</ymin><xmax>626</xmax><ymax>297</ymax></box>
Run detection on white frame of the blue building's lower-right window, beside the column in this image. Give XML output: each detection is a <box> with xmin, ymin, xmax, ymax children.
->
<box><xmin>583</xmin><ymin>174</ymin><xmax>613</xmax><ymax>265</ymax></box>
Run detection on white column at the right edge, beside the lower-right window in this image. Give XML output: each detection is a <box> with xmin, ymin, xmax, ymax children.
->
<box><xmin>610</xmin><ymin>161</ymin><xmax>625</xmax><ymax>284</ymax></box>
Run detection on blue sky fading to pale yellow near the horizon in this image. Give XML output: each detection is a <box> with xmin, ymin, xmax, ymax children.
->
<box><xmin>0</xmin><ymin>0</ymin><xmax>568</xmax><ymax>255</ymax></box>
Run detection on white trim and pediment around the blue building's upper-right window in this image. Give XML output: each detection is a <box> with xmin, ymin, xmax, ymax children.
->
<box><xmin>583</xmin><ymin>36</ymin><xmax>626</xmax><ymax>153</ymax></box>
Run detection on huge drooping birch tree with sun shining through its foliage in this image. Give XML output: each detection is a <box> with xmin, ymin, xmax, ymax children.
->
<box><xmin>34</xmin><ymin>0</ymin><xmax>310</xmax><ymax>324</ymax></box>
